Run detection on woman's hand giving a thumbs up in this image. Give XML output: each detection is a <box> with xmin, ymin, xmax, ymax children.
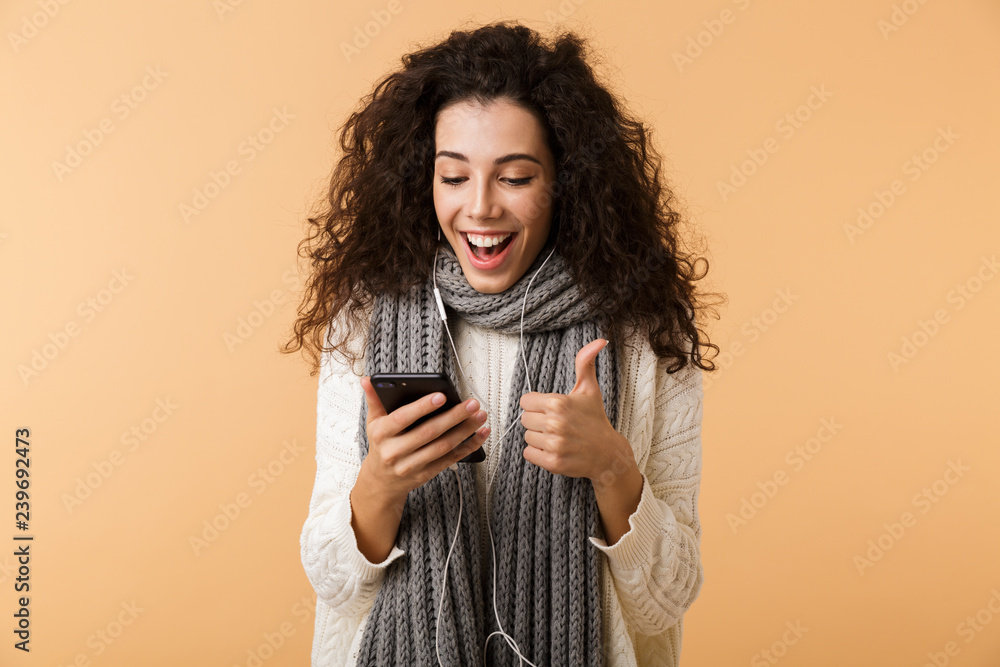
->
<box><xmin>520</xmin><ymin>338</ymin><xmax>638</xmax><ymax>489</ymax></box>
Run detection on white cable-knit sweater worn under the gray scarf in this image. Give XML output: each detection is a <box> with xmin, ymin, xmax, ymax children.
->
<box><xmin>301</xmin><ymin>306</ymin><xmax>704</xmax><ymax>667</ymax></box>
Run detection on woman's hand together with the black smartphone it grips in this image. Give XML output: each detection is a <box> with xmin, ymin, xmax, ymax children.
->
<box><xmin>361</xmin><ymin>373</ymin><xmax>489</xmax><ymax>504</ymax></box>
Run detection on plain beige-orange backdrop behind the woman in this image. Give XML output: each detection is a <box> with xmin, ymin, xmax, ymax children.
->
<box><xmin>0</xmin><ymin>0</ymin><xmax>1000</xmax><ymax>667</ymax></box>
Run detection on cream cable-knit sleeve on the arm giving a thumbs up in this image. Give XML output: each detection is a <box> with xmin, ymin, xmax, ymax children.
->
<box><xmin>590</xmin><ymin>359</ymin><xmax>704</xmax><ymax>635</ymax></box>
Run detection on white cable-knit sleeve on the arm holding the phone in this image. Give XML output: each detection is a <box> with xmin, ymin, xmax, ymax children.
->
<box><xmin>300</xmin><ymin>326</ymin><xmax>404</xmax><ymax>617</ymax></box>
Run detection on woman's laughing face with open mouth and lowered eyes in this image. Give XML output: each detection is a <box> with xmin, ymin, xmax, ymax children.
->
<box><xmin>434</xmin><ymin>100</ymin><xmax>555</xmax><ymax>294</ymax></box>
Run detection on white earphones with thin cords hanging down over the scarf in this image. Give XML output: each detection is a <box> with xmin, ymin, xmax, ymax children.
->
<box><xmin>431</xmin><ymin>236</ymin><xmax>556</xmax><ymax>667</ymax></box>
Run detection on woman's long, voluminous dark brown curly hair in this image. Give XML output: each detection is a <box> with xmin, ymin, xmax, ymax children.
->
<box><xmin>281</xmin><ymin>21</ymin><xmax>719</xmax><ymax>375</ymax></box>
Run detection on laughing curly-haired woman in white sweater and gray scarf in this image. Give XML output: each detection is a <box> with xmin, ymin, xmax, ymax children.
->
<box><xmin>286</xmin><ymin>22</ymin><xmax>718</xmax><ymax>667</ymax></box>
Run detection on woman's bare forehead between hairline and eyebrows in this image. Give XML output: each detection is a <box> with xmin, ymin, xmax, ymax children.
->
<box><xmin>434</xmin><ymin>100</ymin><xmax>544</xmax><ymax>155</ymax></box>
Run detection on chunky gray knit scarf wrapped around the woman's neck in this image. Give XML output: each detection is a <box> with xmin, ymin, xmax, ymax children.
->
<box><xmin>357</xmin><ymin>240</ymin><xmax>618</xmax><ymax>667</ymax></box>
